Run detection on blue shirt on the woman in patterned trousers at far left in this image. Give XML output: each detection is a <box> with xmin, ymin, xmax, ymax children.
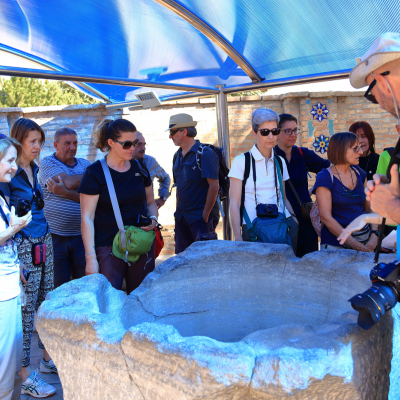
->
<box><xmin>0</xmin><ymin>161</ymin><xmax>48</xmax><ymax>238</ymax></box>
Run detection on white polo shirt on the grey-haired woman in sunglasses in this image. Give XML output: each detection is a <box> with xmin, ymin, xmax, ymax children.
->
<box><xmin>229</xmin><ymin>145</ymin><xmax>289</xmax><ymax>223</ymax></box>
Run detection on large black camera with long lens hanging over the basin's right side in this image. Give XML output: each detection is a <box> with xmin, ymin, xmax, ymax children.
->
<box><xmin>349</xmin><ymin>261</ymin><xmax>400</xmax><ymax>330</ymax></box>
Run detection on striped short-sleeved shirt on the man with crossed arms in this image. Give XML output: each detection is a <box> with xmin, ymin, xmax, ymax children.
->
<box><xmin>39</xmin><ymin>153</ymin><xmax>91</xmax><ymax>236</ymax></box>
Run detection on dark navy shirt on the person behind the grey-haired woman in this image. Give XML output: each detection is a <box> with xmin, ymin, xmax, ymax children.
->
<box><xmin>275</xmin><ymin>146</ymin><xmax>330</xmax><ymax>218</ymax></box>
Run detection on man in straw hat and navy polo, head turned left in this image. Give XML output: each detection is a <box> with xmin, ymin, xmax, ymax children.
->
<box><xmin>167</xmin><ymin>113</ymin><xmax>219</xmax><ymax>254</ymax></box>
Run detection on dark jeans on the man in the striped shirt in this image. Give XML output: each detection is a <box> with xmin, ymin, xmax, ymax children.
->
<box><xmin>51</xmin><ymin>233</ymin><xmax>86</xmax><ymax>288</ymax></box>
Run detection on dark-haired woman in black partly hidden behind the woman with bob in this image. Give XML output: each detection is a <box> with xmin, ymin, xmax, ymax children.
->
<box><xmin>349</xmin><ymin>121</ymin><xmax>379</xmax><ymax>181</ymax></box>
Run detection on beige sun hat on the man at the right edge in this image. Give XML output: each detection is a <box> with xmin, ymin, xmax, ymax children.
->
<box><xmin>349</xmin><ymin>32</ymin><xmax>400</xmax><ymax>89</ymax></box>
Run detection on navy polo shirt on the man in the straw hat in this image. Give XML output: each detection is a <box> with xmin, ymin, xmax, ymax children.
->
<box><xmin>173</xmin><ymin>140</ymin><xmax>219</xmax><ymax>224</ymax></box>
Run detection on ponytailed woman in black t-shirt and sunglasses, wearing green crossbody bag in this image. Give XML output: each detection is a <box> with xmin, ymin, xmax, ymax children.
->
<box><xmin>78</xmin><ymin>119</ymin><xmax>158</xmax><ymax>294</ymax></box>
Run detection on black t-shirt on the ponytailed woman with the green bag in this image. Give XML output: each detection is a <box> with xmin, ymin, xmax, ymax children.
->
<box><xmin>78</xmin><ymin>160</ymin><xmax>151</xmax><ymax>247</ymax></box>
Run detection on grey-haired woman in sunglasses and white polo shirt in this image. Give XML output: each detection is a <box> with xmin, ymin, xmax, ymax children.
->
<box><xmin>229</xmin><ymin>108</ymin><xmax>297</xmax><ymax>244</ymax></box>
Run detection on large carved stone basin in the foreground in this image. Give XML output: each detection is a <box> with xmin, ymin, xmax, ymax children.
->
<box><xmin>36</xmin><ymin>241</ymin><xmax>400</xmax><ymax>400</ymax></box>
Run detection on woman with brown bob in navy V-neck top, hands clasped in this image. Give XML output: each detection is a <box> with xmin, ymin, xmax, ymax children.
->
<box><xmin>314</xmin><ymin>132</ymin><xmax>378</xmax><ymax>252</ymax></box>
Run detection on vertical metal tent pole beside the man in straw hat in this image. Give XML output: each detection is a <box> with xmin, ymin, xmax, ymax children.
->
<box><xmin>215</xmin><ymin>85</ymin><xmax>232</xmax><ymax>240</ymax></box>
